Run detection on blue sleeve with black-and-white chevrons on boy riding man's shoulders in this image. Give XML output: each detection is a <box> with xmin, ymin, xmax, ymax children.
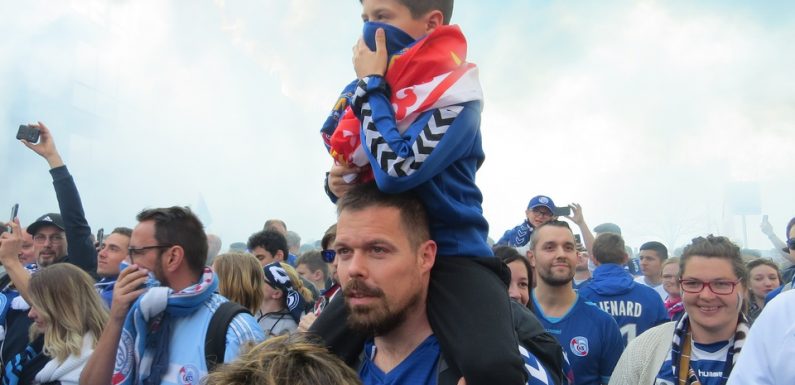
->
<box><xmin>352</xmin><ymin>77</ymin><xmax>482</xmax><ymax>193</ymax></box>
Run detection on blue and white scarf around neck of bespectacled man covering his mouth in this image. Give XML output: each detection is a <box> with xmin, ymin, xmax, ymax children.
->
<box><xmin>111</xmin><ymin>267</ymin><xmax>218</xmax><ymax>385</ymax></box>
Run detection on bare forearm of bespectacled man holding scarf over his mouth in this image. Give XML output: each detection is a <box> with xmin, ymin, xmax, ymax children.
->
<box><xmin>80</xmin><ymin>318</ymin><xmax>124</xmax><ymax>385</ymax></box>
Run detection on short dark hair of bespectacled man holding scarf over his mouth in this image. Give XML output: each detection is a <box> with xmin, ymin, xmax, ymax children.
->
<box><xmin>136</xmin><ymin>206</ymin><xmax>207</xmax><ymax>274</ymax></box>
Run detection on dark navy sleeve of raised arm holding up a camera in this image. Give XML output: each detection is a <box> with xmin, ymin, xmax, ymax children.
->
<box><xmin>50</xmin><ymin>166</ymin><xmax>97</xmax><ymax>277</ymax></box>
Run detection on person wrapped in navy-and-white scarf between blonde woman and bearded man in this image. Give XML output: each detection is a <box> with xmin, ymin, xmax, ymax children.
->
<box><xmin>255</xmin><ymin>262</ymin><xmax>313</xmax><ymax>337</ymax></box>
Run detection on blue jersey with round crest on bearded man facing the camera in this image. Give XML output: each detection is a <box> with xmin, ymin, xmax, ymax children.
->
<box><xmin>533</xmin><ymin>292</ymin><xmax>624</xmax><ymax>385</ymax></box>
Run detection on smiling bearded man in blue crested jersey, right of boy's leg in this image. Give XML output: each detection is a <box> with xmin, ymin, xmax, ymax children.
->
<box><xmin>530</xmin><ymin>220</ymin><xmax>624</xmax><ymax>385</ymax></box>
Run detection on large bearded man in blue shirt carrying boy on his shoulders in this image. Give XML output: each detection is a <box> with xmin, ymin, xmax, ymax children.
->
<box><xmin>334</xmin><ymin>185</ymin><xmax>555</xmax><ymax>385</ymax></box>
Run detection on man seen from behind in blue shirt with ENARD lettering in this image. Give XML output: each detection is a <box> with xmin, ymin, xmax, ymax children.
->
<box><xmin>579</xmin><ymin>233</ymin><xmax>669</xmax><ymax>346</ymax></box>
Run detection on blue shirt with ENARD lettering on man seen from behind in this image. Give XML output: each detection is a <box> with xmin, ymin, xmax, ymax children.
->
<box><xmin>579</xmin><ymin>263</ymin><xmax>670</xmax><ymax>346</ymax></box>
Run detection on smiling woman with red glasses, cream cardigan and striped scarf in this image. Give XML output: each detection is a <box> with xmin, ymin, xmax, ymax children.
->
<box><xmin>610</xmin><ymin>235</ymin><xmax>748</xmax><ymax>385</ymax></box>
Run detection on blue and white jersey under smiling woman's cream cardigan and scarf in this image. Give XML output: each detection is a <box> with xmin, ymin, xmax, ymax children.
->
<box><xmin>654</xmin><ymin>341</ymin><xmax>731</xmax><ymax>385</ymax></box>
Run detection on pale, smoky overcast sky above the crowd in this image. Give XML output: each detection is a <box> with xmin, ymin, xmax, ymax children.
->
<box><xmin>0</xmin><ymin>0</ymin><xmax>795</xmax><ymax>256</ymax></box>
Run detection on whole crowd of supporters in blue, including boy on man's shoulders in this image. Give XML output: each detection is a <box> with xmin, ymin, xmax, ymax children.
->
<box><xmin>0</xmin><ymin>0</ymin><xmax>795</xmax><ymax>385</ymax></box>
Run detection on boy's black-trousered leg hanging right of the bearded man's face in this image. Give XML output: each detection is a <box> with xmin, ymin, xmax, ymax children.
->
<box><xmin>428</xmin><ymin>257</ymin><xmax>527</xmax><ymax>385</ymax></box>
